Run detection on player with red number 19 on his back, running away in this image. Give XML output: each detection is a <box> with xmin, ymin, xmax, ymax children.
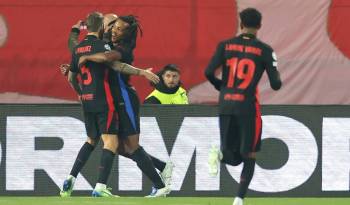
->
<box><xmin>205</xmin><ymin>8</ymin><xmax>282</xmax><ymax>205</ymax></box>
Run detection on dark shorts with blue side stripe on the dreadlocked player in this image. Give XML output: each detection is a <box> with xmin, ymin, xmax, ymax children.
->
<box><xmin>116</xmin><ymin>86</ymin><xmax>140</xmax><ymax>138</ymax></box>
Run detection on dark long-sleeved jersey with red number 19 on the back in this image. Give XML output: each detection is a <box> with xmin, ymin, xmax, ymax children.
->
<box><xmin>205</xmin><ymin>34</ymin><xmax>281</xmax><ymax>114</ymax></box>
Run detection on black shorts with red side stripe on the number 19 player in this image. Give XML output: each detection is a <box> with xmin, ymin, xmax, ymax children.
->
<box><xmin>219</xmin><ymin>113</ymin><xmax>262</xmax><ymax>155</ymax></box>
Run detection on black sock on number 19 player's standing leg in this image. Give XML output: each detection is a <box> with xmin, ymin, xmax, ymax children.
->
<box><xmin>238</xmin><ymin>158</ymin><xmax>255</xmax><ymax>199</ymax></box>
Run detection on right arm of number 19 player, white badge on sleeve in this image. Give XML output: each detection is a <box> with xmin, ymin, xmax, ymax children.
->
<box><xmin>265</xmin><ymin>49</ymin><xmax>282</xmax><ymax>90</ymax></box>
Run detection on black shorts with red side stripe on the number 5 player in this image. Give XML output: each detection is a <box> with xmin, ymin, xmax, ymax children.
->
<box><xmin>84</xmin><ymin>111</ymin><xmax>119</xmax><ymax>139</ymax></box>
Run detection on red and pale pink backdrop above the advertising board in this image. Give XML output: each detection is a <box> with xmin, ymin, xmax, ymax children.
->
<box><xmin>0</xmin><ymin>0</ymin><xmax>350</xmax><ymax>104</ymax></box>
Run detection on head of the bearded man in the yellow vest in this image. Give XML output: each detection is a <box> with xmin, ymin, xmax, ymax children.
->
<box><xmin>160</xmin><ymin>64</ymin><xmax>180</xmax><ymax>88</ymax></box>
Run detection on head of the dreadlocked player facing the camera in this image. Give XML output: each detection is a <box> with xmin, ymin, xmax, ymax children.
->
<box><xmin>112</xmin><ymin>15</ymin><xmax>142</xmax><ymax>48</ymax></box>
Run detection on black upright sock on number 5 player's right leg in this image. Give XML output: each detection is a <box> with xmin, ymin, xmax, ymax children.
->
<box><xmin>97</xmin><ymin>149</ymin><xmax>115</xmax><ymax>184</ymax></box>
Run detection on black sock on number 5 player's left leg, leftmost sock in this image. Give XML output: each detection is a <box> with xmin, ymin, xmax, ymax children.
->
<box><xmin>70</xmin><ymin>142</ymin><xmax>95</xmax><ymax>178</ymax></box>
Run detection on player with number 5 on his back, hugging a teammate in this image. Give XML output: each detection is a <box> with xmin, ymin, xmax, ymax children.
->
<box><xmin>60</xmin><ymin>12</ymin><xmax>123</xmax><ymax>197</ymax></box>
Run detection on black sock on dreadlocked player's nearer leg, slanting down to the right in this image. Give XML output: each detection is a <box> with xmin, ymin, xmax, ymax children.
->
<box><xmin>131</xmin><ymin>146</ymin><xmax>165</xmax><ymax>189</ymax></box>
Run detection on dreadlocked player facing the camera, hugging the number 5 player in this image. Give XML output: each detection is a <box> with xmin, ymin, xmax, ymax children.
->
<box><xmin>79</xmin><ymin>15</ymin><xmax>174</xmax><ymax>197</ymax></box>
